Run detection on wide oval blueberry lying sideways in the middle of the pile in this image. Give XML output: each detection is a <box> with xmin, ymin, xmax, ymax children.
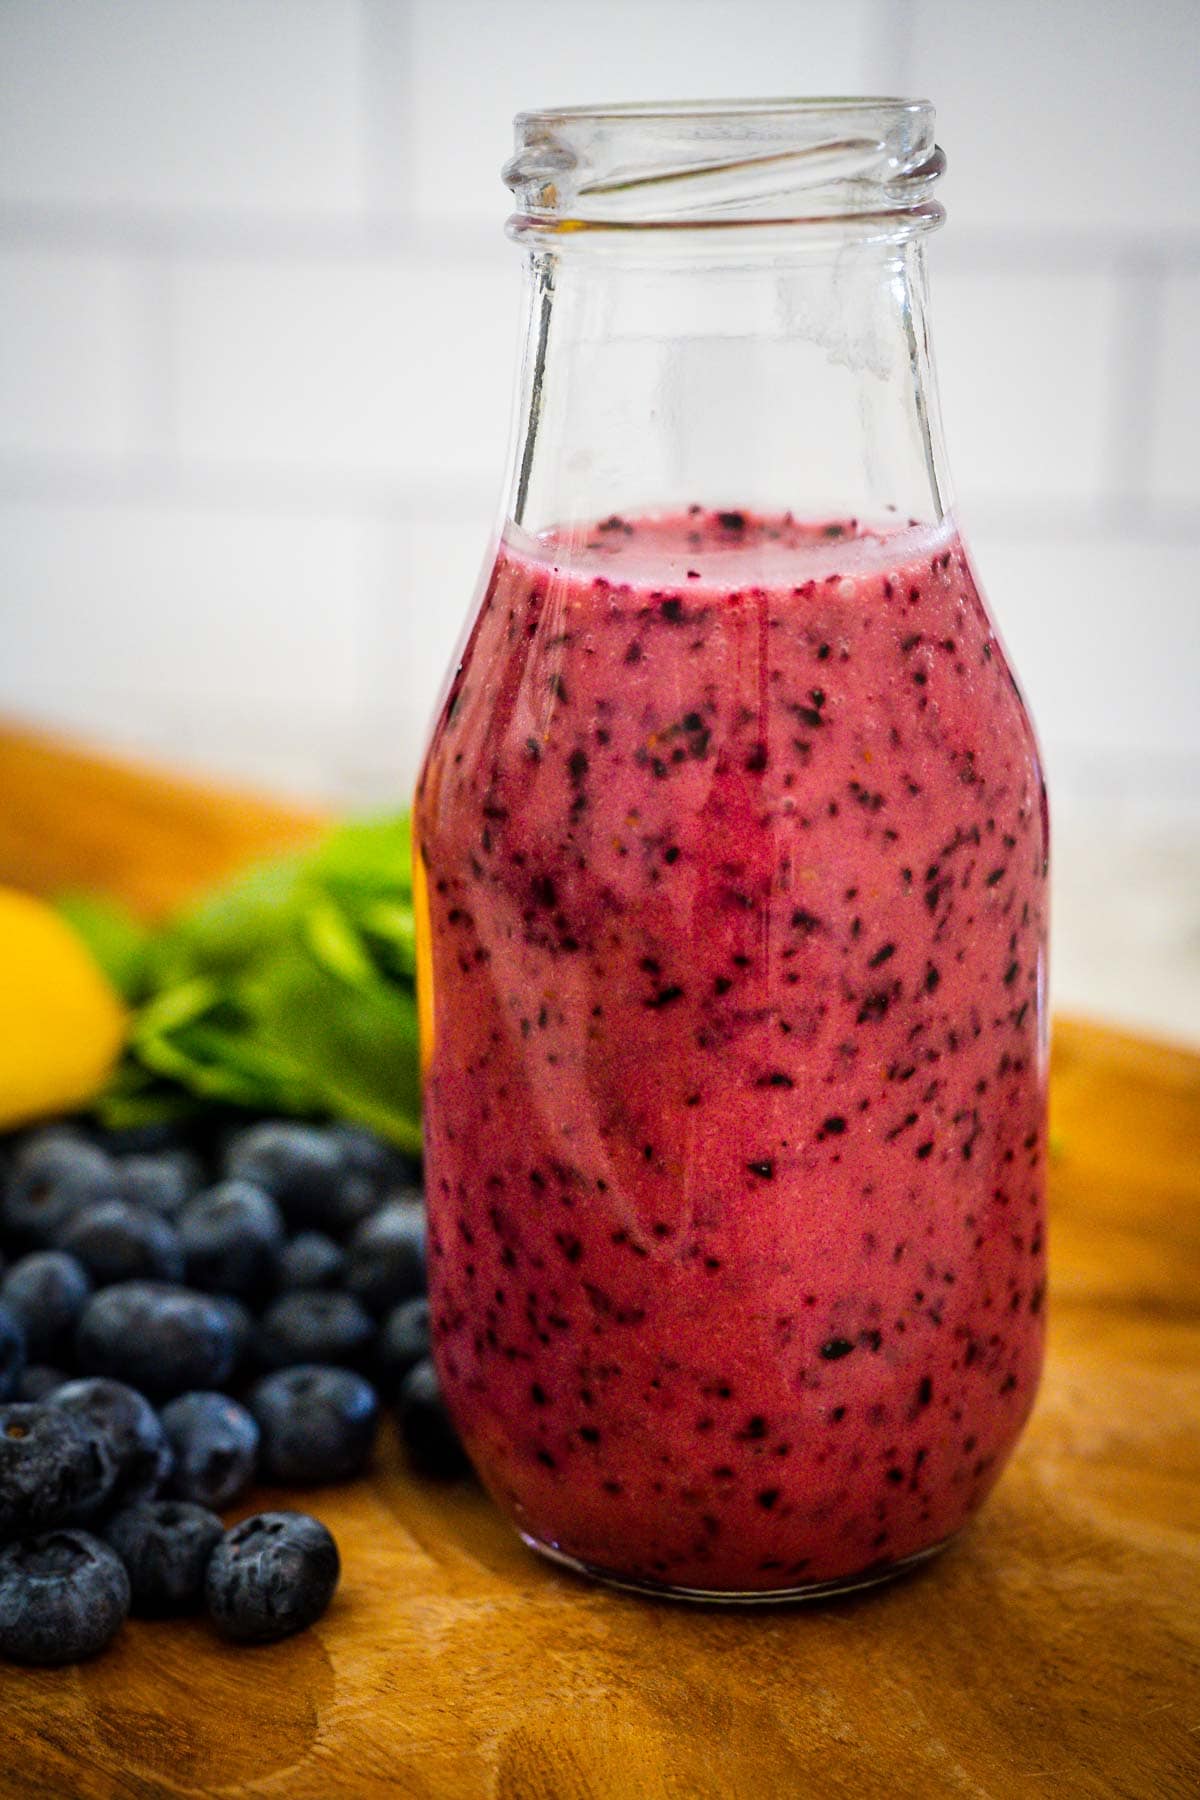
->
<box><xmin>76</xmin><ymin>1282</ymin><xmax>234</xmax><ymax>1400</ymax></box>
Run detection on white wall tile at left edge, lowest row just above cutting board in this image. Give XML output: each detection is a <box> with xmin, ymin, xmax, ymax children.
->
<box><xmin>0</xmin><ymin>502</ymin><xmax>371</xmax><ymax>734</ymax></box>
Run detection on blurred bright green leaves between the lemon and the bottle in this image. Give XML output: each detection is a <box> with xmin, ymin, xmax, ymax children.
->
<box><xmin>63</xmin><ymin>815</ymin><xmax>421</xmax><ymax>1152</ymax></box>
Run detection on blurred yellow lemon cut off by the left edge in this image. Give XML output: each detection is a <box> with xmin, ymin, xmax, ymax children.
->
<box><xmin>0</xmin><ymin>887</ymin><xmax>126</xmax><ymax>1130</ymax></box>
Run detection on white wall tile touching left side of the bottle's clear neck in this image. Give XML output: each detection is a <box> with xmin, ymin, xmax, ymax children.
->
<box><xmin>175</xmin><ymin>252</ymin><xmax>520</xmax><ymax>486</ymax></box>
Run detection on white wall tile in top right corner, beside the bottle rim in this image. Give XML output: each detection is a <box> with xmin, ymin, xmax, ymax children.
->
<box><xmin>909</xmin><ymin>0</ymin><xmax>1200</xmax><ymax>238</ymax></box>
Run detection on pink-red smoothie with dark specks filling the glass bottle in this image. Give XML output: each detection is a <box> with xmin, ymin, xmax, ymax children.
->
<box><xmin>416</xmin><ymin>508</ymin><xmax>1047</xmax><ymax>1595</ymax></box>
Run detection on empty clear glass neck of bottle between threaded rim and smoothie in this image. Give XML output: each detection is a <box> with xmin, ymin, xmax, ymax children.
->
<box><xmin>507</xmin><ymin>227</ymin><xmax>950</xmax><ymax>533</ymax></box>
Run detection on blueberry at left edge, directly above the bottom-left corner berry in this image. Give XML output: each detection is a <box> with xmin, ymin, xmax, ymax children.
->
<box><xmin>0</xmin><ymin>1400</ymin><xmax>113</xmax><ymax>1543</ymax></box>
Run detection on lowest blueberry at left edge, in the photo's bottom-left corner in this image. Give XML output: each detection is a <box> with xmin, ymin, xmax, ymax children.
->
<box><xmin>0</xmin><ymin>1532</ymin><xmax>130</xmax><ymax>1663</ymax></box>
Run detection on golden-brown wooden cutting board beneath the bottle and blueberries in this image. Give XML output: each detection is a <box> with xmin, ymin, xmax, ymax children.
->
<box><xmin>0</xmin><ymin>734</ymin><xmax>1200</xmax><ymax>1800</ymax></box>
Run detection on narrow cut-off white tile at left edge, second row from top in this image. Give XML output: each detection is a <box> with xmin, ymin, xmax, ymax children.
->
<box><xmin>0</xmin><ymin>243</ymin><xmax>144</xmax><ymax>457</ymax></box>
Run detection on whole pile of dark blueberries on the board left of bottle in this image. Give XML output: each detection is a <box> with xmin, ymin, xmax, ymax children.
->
<box><xmin>0</xmin><ymin>1120</ymin><xmax>468</xmax><ymax>1663</ymax></box>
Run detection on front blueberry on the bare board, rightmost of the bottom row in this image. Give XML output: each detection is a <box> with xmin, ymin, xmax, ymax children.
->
<box><xmin>205</xmin><ymin>1512</ymin><xmax>342</xmax><ymax>1643</ymax></box>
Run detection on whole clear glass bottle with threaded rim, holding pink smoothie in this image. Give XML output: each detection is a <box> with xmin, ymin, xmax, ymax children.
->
<box><xmin>416</xmin><ymin>99</ymin><xmax>1047</xmax><ymax>1600</ymax></box>
